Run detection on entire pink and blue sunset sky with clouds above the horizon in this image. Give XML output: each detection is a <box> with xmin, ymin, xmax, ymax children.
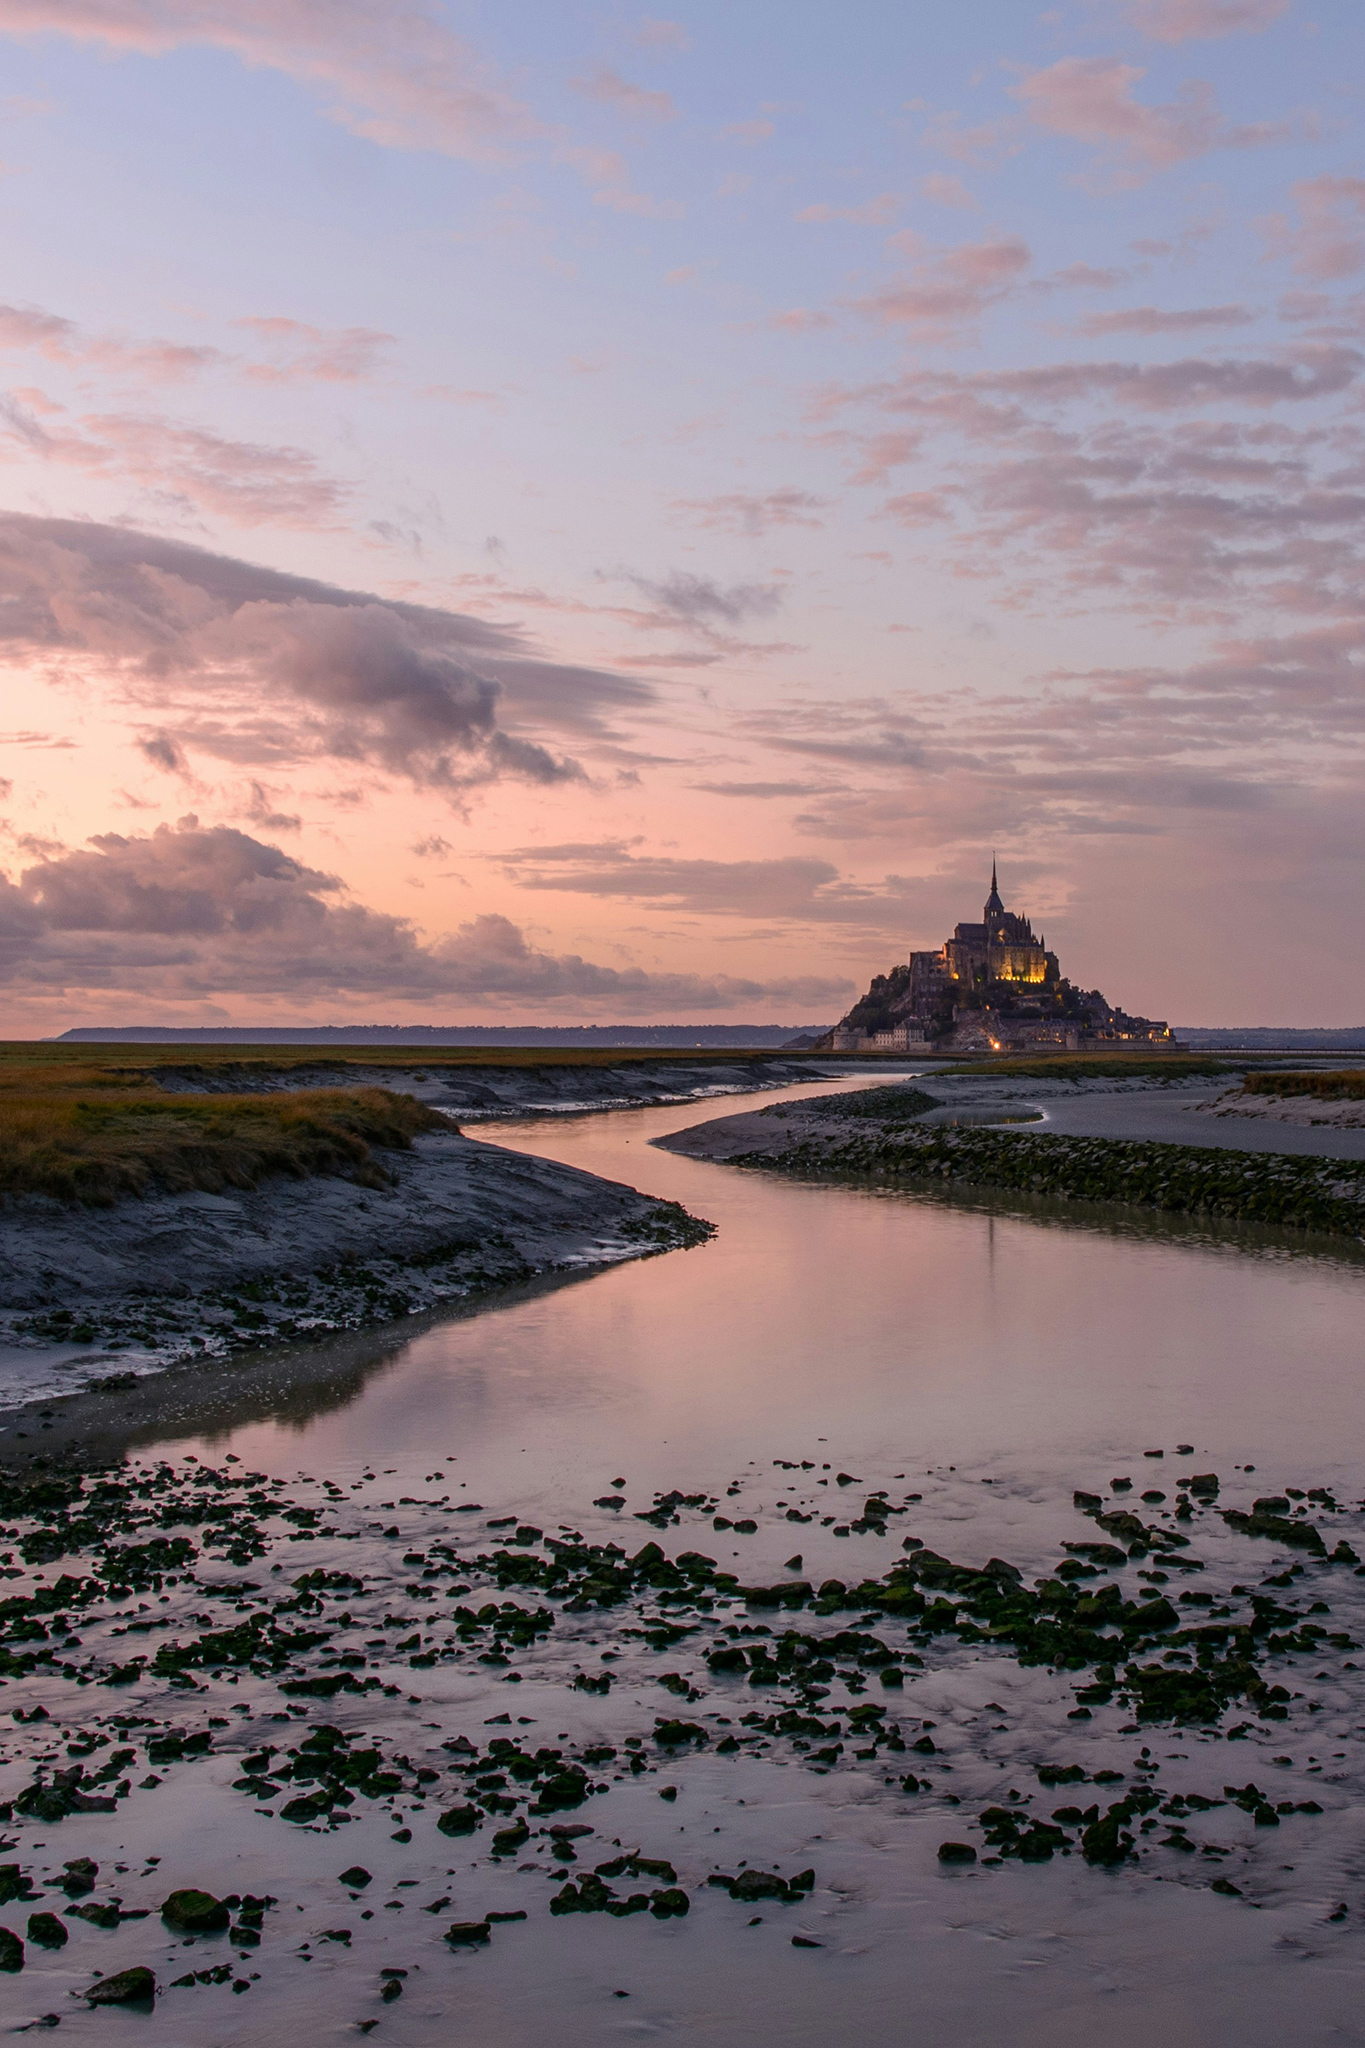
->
<box><xmin>0</xmin><ymin>0</ymin><xmax>1365</xmax><ymax>1036</ymax></box>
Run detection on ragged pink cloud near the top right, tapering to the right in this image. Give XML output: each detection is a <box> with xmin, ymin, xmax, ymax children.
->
<box><xmin>1011</xmin><ymin>57</ymin><xmax>1295</xmax><ymax>184</ymax></box>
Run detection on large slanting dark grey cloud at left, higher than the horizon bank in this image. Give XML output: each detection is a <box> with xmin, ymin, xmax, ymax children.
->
<box><xmin>0</xmin><ymin>512</ymin><xmax>653</xmax><ymax>788</ymax></box>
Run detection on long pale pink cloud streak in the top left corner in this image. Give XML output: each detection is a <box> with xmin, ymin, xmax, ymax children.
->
<box><xmin>0</xmin><ymin>0</ymin><xmax>534</xmax><ymax>158</ymax></box>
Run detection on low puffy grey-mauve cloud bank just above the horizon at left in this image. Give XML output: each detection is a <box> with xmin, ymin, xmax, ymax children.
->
<box><xmin>0</xmin><ymin>817</ymin><xmax>849</xmax><ymax>1018</ymax></box>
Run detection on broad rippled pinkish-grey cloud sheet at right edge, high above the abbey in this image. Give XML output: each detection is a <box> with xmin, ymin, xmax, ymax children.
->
<box><xmin>817</xmin><ymin>346</ymin><xmax>1365</xmax><ymax>623</ymax></box>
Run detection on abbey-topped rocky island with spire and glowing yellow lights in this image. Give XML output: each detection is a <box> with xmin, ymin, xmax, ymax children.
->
<box><xmin>821</xmin><ymin>862</ymin><xmax>1175</xmax><ymax>1053</ymax></box>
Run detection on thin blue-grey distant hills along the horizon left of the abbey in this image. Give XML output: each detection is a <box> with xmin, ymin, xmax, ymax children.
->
<box><xmin>57</xmin><ymin>1024</ymin><xmax>829</xmax><ymax>1051</ymax></box>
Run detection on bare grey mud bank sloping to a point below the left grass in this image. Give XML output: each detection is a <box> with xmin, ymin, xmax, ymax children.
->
<box><xmin>0</xmin><ymin>1130</ymin><xmax>708</xmax><ymax>1405</ymax></box>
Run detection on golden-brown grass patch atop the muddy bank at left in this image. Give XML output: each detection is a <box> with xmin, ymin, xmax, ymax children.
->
<box><xmin>0</xmin><ymin>1067</ymin><xmax>450</xmax><ymax>1204</ymax></box>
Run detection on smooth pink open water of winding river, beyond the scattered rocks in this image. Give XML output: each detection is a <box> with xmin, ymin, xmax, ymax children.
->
<box><xmin>194</xmin><ymin>1092</ymin><xmax>1365</xmax><ymax>1561</ymax></box>
